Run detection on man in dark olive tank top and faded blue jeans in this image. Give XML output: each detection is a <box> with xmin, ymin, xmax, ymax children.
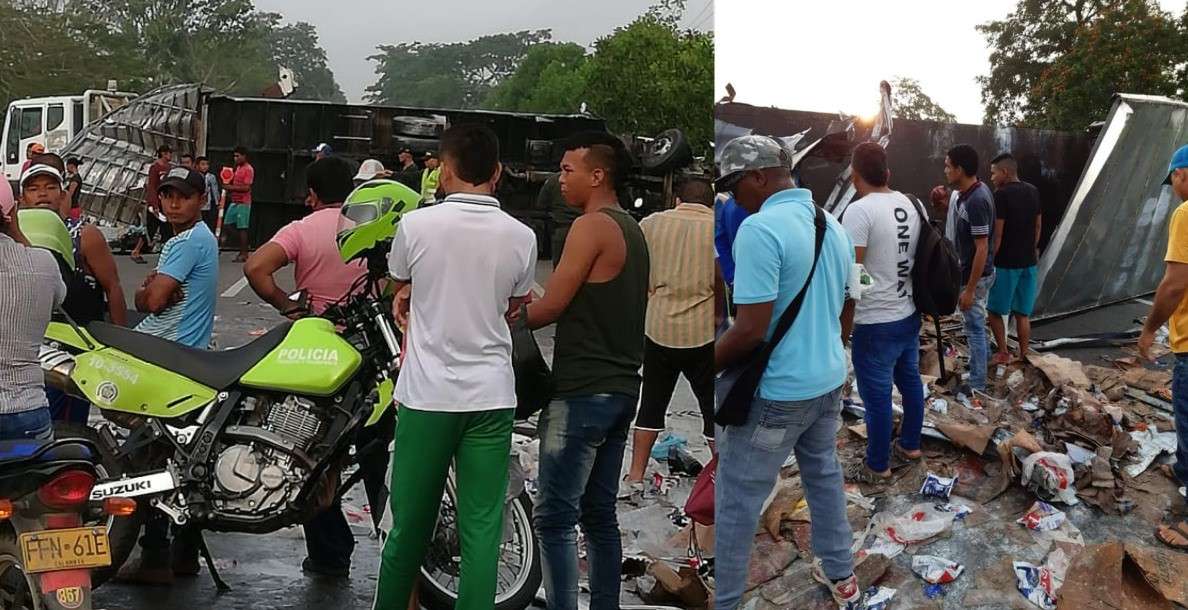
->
<box><xmin>527</xmin><ymin>132</ymin><xmax>649</xmax><ymax>610</ymax></box>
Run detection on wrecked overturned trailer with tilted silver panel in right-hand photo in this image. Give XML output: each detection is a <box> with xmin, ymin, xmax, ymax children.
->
<box><xmin>715</xmin><ymin>94</ymin><xmax>1188</xmax><ymax>319</ymax></box>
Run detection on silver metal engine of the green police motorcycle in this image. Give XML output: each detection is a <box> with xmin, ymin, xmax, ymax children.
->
<box><xmin>214</xmin><ymin>396</ymin><xmax>324</xmax><ymax>514</ymax></box>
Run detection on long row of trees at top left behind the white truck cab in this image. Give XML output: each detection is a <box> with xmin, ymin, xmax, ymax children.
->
<box><xmin>0</xmin><ymin>0</ymin><xmax>345</xmax><ymax>107</ymax></box>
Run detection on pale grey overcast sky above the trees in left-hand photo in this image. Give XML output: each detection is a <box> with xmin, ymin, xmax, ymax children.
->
<box><xmin>255</xmin><ymin>0</ymin><xmax>713</xmax><ymax>102</ymax></box>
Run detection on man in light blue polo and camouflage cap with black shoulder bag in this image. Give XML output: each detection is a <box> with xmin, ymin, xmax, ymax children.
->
<box><xmin>714</xmin><ymin>136</ymin><xmax>860</xmax><ymax>610</ymax></box>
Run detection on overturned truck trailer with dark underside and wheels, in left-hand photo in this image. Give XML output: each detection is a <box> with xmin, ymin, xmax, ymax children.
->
<box><xmin>62</xmin><ymin>84</ymin><xmax>691</xmax><ymax>252</ymax></box>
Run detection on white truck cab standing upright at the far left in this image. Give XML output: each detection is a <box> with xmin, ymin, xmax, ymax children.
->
<box><xmin>0</xmin><ymin>89</ymin><xmax>137</xmax><ymax>182</ymax></box>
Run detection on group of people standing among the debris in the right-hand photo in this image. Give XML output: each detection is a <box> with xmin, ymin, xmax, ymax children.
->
<box><xmin>714</xmin><ymin>136</ymin><xmax>1188</xmax><ymax>610</ymax></box>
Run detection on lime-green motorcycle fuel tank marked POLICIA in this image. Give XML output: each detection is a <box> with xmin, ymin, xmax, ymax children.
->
<box><xmin>239</xmin><ymin>317</ymin><xmax>364</xmax><ymax>396</ymax></box>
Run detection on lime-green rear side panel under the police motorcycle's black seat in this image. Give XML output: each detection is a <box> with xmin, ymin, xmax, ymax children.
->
<box><xmin>70</xmin><ymin>348</ymin><xmax>217</xmax><ymax>417</ymax></box>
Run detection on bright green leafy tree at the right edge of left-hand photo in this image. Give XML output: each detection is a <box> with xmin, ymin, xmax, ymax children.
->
<box><xmin>586</xmin><ymin>0</ymin><xmax>714</xmax><ymax>151</ymax></box>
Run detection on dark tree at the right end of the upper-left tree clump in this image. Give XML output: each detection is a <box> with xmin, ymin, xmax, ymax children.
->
<box><xmin>264</xmin><ymin>13</ymin><xmax>347</xmax><ymax>103</ymax></box>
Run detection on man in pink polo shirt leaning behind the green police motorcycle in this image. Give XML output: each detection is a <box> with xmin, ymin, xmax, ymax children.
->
<box><xmin>244</xmin><ymin>157</ymin><xmax>382</xmax><ymax>578</ymax></box>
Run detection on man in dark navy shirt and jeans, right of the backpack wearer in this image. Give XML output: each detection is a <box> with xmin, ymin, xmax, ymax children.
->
<box><xmin>944</xmin><ymin>144</ymin><xmax>994</xmax><ymax>395</ymax></box>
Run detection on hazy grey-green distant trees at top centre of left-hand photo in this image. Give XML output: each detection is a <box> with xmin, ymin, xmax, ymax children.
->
<box><xmin>367</xmin><ymin>30</ymin><xmax>551</xmax><ymax>108</ymax></box>
